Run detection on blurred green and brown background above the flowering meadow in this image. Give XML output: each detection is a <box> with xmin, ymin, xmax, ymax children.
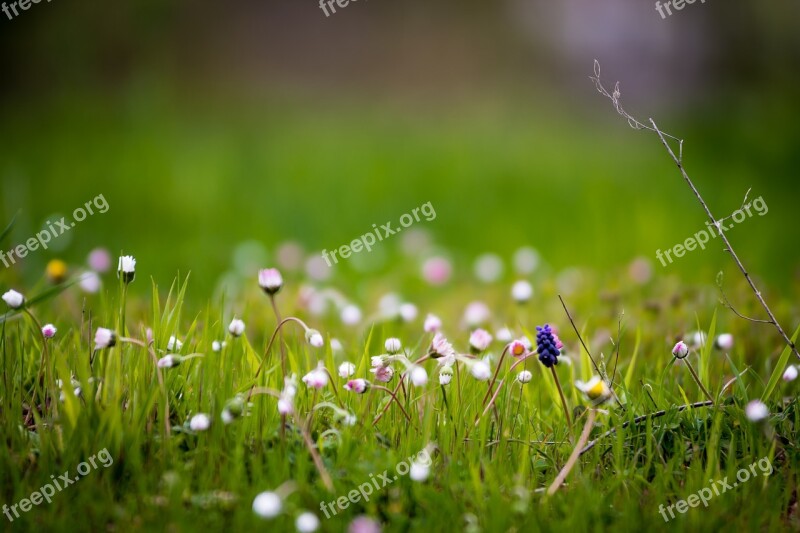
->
<box><xmin>0</xmin><ymin>0</ymin><xmax>800</xmax><ymax>297</ymax></box>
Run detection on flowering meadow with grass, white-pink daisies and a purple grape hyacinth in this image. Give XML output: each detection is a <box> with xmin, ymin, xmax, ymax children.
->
<box><xmin>0</xmin><ymin>225</ymin><xmax>798</xmax><ymax>531</ymax></box>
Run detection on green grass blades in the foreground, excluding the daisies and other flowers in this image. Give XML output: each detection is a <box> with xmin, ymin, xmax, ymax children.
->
<box><xmin>0</xmin><ymin>249</ymin><xmax>800</xmax><ymax>531</ymax></box>
